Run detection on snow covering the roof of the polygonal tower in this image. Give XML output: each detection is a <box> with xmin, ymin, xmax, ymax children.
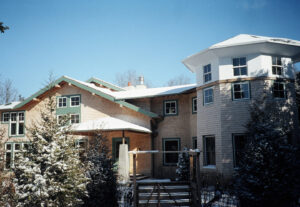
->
<box><xmin>209</xmin><ymin>34</ymin><xmax>300</xmax><ymax>49</ymax></box>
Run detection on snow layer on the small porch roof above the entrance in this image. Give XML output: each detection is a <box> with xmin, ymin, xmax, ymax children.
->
<box><xmin>72</xmin><ymin>117</ymin><xmax>151</xmax><ymax>133</ymax></box>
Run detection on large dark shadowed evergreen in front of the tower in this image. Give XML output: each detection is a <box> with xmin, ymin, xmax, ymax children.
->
<box><xmin>234</xmin><ymin>100</ymin><xmax>300</xmax><ymax>207</ymax></box>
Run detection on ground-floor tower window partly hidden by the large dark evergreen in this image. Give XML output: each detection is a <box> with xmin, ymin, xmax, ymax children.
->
<box><xmin>232</xmin><ymin>134</ymin><xmax>247</xmax><ymax>167</ymax></box>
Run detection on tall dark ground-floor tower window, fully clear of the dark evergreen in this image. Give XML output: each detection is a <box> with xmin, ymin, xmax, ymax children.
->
<box><xmin>203</xmin><ymin>136</ymin><xmax>216</xmax><ymax>166</ymax></box>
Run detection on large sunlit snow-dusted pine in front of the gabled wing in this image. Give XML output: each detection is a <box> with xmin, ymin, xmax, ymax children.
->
<box><xmin>14</xmin><ymin>97</ymin><xmax>88</xmax><ymax>207</ymax></box>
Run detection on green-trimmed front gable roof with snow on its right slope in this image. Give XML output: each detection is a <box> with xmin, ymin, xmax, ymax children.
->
<box><xmin>8</xmin><ymin>76</ymin><xmax>158</xmax><ymax>118</ymax></box>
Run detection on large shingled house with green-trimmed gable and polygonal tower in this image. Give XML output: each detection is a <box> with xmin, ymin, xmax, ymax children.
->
<box><xmin>0</xmin><ymin>35</ymin><xmax>300</xmax><ymax>180</ymax></box>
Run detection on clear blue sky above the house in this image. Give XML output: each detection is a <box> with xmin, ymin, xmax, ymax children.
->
<box><xmin>0</xmin><ymin>0</ymin><xmax>300</xmax><ymax>97</ymax></box>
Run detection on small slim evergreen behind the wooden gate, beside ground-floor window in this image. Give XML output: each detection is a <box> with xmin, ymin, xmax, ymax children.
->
<box><xmin>176</xmin><ymin>147</ymin><xmax>190</xmax><ymax>181</ymax></box>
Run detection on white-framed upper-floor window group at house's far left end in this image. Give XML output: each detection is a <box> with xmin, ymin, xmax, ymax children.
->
<box><xmin>3</xmin><ymin>112</ymin><xmax>25</xmax><ymax>136</ymax></box>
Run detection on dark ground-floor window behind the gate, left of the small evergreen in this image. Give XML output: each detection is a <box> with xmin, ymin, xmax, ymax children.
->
<box><xmin>163</xmin><ymin>138</ymin><xmax>180</xmax><ymax>165</ymax></box>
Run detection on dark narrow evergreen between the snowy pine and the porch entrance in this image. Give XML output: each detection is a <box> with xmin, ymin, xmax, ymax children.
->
<box><xmin>85</xmin><ymin>133</ymin><xmax>117</xmax><ymax>207</ymax></box>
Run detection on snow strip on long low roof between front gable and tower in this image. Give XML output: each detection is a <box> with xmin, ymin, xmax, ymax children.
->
<box><xmin>113</xmin><ymin>84</ymin><xmax>197</xmax><ymax>100</ymax></box>
